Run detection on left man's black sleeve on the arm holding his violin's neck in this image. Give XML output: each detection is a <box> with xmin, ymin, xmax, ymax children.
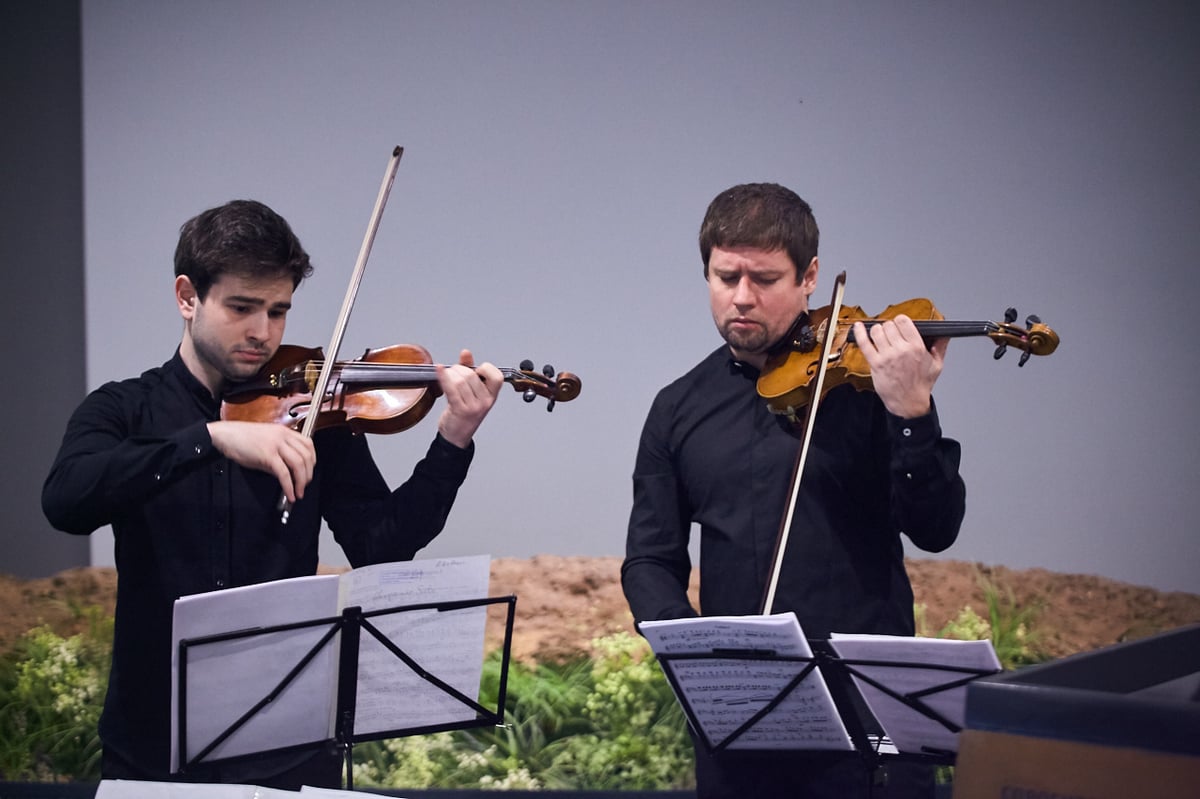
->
<box><xmin>318</xmin><ymin>428</ymin><xmax>475</xmax><ymax>567</ymax></box>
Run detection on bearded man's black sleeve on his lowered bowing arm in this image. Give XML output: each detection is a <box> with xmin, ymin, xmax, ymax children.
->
<box><xmin>620</xmin><ymin>388</ymin><xmax>697</xmax><ymax>621</ymax></box>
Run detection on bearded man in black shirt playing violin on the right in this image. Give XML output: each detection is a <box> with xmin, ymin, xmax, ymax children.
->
<box><xmin>622</xmin><ymin>184</ymin><xmax>965</xmax><ymax>799</ymax></box>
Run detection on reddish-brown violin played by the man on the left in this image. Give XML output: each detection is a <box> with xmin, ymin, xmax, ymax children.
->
<box><xmin>221</xmin><ymin>344</ymin><xmax>582</xmax><ymax>433</ymax></box>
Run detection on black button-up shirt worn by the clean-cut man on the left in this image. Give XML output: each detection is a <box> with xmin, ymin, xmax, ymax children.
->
<box><xmin>42</xmin><ymin>352</ymin><xmax>474</xmax><ymax>776</ymax></box>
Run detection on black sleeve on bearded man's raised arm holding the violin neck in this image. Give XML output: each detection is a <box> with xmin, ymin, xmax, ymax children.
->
<box><xmin>887</xmin><ymin>398</ymin><xmax>966</xmax><ymax>552</ymax></box>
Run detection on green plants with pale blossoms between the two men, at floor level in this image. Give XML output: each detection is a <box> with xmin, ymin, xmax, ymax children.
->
<box><xmin>355</xmin><ymin>633</ymin><xmax>692</xmax><ymax>789</ymax></box>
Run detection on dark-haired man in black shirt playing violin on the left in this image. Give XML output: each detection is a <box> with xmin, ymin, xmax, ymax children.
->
<box><xmin>42</xmin><ymin>200</ymin><xmax>503</xmax><ymax>788</ymax></box>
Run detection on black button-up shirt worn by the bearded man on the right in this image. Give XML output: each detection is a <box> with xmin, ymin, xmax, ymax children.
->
<box><xmin>622</xmin><ymin>347</ymin><xmax>965</xmax><ymax>638</ymax></box>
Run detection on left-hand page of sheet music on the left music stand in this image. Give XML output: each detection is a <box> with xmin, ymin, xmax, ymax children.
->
<box><xmin>170</xmin><ymin>575</ymin><xmax>338</xmax><ymax>771</ymax></box>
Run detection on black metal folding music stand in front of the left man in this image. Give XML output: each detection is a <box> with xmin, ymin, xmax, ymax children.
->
<box><xmin>176</xmin><ymin>595</ymin><xmax>516</xmax><ymax>791</ymax></box>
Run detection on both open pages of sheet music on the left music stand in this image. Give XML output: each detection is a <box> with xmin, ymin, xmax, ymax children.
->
<box><xmin>170</xmin><ymin>555</ymin><xmax>491</xmax><ymax>771</ymax></box>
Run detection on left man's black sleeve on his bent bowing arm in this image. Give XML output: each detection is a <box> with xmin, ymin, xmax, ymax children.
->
<box><xmin>42</xmin><ymin>385</ymin><xmax>216</xmax><ymax>535</ymax></box>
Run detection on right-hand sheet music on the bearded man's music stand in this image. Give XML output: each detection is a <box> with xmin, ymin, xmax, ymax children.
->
<box><xmin>829</xmin><ymin>632</ymin><xmax>1001</xmax><ymax>753</ymax></box>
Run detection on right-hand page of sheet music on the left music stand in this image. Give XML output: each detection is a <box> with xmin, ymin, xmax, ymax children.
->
<box><xmin>341</xmin><ymin>555</ymin><xmax>491</xmax><ymax>735</ymax></box>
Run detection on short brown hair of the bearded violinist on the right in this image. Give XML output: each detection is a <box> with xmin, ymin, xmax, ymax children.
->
<box><xmin>700</xmin><ymin>184</ymin><xmax>821</xmax><ymax>283</ymax></box>
